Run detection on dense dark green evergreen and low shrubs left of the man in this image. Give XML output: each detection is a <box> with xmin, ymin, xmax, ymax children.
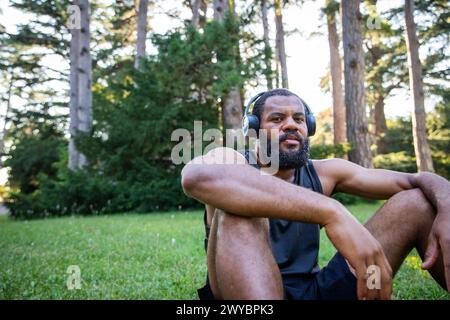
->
<box><xmin>8</xmin><ymin>16</ymin><xmax>261</xmax><ymax>218</ymax></box>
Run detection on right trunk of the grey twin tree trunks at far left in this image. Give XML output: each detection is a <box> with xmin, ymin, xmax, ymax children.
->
<box><xmin>78</xmin><ymin>0</ymin><xmax>92</xmax><ymax>168</ymax></box>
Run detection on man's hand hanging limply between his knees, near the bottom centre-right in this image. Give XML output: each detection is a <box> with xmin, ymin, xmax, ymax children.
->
<box><xmin>324</xmin><ymin>208</ymin><xmax>392</xmax><ymax>300</ymax></box>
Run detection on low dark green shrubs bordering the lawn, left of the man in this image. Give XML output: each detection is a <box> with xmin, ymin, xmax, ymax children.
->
<box><xmin>6</xmin><ymin>168</ymin><xmax>200</xmax><ymax>219</ymax></box>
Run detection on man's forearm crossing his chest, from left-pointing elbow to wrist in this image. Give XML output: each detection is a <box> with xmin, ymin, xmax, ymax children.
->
<box><xmin>183</xmin><ymin>164</ymin><xmax>346</xmax><ymax>225</ymax></box>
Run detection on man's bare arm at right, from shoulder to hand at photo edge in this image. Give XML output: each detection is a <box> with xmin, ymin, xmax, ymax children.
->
<box><xmin>315</xmin><ymin>159</ymin><xmax>450</xmax><ymax>291</ymax></box>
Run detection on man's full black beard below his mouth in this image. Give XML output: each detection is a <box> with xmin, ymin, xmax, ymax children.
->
<box><xmin>261</xmin><ymin>135</ymin><xmax>310</xmax><ymax>170</ymax></box>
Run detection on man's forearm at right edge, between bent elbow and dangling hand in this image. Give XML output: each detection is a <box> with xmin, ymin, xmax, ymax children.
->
<box><xmin>411</xmin><ymin>172</ymin><xmax>450</xmax><ymax>214</ymax></box>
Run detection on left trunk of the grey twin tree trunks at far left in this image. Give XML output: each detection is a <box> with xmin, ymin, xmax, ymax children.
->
<box><xmin>68</xmin><ymin>1</ymin><xmax>80</xmax><ymax>171</ymax></box>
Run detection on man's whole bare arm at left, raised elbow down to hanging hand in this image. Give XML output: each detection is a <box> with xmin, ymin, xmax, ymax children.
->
<box><xmin>182</xmin><ymin>148</ymin><xmax>392</xmax><ymax>299</ymax></box>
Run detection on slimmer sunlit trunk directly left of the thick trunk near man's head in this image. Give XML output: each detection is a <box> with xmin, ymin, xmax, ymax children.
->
<box><xmin>327</xmin><ymin>0</ymin><xmax>346</xmax><ymax>144</ymax></box>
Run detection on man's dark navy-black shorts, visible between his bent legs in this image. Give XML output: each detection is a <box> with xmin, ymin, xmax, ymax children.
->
<box><xmin>198</xmin><ymin>252</ymin><xmax>357</xmax><ymax>300</ymax></box>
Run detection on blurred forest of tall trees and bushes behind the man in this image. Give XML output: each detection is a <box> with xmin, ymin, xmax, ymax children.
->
<box><xmin>0</xmin><ymin>0</ymin><xmax>450</xmax><ymax>219</ymax></box>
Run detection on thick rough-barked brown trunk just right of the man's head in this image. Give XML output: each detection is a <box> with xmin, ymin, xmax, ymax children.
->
<box><xmin>341</xmin><ymin>0</ymin><xmax>372</xmax><ymax>168</ymax></box>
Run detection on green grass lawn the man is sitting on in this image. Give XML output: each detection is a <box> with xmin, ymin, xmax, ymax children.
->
<box><xmin>0</xmin><ymin>204</ymin><xmax>450</xmax><ymax>299</ymax></box>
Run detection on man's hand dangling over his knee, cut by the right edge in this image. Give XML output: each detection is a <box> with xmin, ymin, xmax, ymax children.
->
<box><xmin>422</xmin><ymin>212</ymin><xmax>450</xmax><ymax>291</ymax></box>
